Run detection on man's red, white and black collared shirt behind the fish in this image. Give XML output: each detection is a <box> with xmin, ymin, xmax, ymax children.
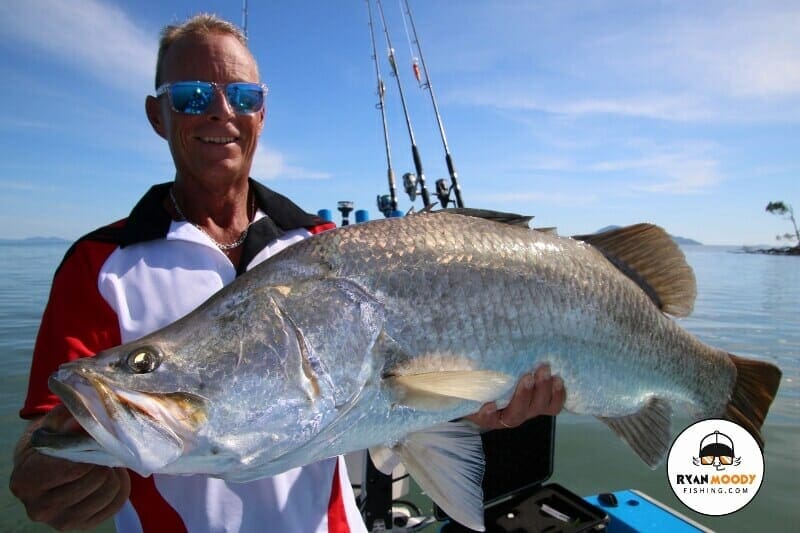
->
<box><xmin>20</xmin><ymin>180</ymin><xmax>366</xmax><ymax>533</ymax></box>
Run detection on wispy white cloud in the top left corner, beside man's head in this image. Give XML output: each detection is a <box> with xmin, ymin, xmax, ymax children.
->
<box><xmin>0</xmin><ymin>0</ymin><xmax>158</xmax><ymax>95</ymax></box>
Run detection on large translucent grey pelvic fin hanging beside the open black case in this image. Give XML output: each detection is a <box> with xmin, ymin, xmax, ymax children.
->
<box><xmin>393</xmin><ymin>422</ymin><xmax>484</xmax><ymax>531</ymax></box>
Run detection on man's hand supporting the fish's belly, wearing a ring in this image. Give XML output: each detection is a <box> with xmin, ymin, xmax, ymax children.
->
<box><xmin>465</xmin><ymin>365</ymin><xmax>567</xmax><ymax>429</ymax></box>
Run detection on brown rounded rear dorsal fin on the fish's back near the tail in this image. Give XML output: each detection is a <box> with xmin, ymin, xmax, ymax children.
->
<box><xmin>573</xmin><ymin>224</ymin><xmax>697</xmax><ymax>316</ymax></box>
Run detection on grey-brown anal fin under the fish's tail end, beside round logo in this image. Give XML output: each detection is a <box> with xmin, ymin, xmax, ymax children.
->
<box><xmin>597</xmin><ymin>398</ymin><xmax>672</xmax><ymax>469</ymax></box>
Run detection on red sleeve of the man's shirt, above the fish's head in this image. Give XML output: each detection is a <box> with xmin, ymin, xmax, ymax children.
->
<box><xmin>19</xmin><ymin>240</ymin><xmax>121</xmax><ymax>418</ymax></box>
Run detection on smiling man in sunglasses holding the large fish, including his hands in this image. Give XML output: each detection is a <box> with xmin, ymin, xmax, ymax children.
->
<box><xmin>10</xmin><ymin>15</ymin><xmax>564</xmax><ymax>532</ymax></box>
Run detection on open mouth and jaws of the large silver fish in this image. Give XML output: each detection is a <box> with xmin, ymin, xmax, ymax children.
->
<box><xmin>32</xmin><ymin>366</ymin><xmax>207</xmax><ymax>476</ymax></box>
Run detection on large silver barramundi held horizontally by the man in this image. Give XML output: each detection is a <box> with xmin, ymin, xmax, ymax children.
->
<box><xmin>34</xmin><ymin>211</ymin><xmax>780</xmax><ymax>529</ymax></box>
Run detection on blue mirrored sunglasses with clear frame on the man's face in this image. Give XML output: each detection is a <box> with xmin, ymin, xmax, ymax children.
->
<box><xmin>156</xmin><ymin>81</ymin><xmax>267</xmax><ymax>115</ymax></box>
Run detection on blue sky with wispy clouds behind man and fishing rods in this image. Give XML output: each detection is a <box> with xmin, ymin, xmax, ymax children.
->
<box><xmin>0</xmin><ymin>0</ymin><xmax>800</xmax><ymax>245</ymax></box>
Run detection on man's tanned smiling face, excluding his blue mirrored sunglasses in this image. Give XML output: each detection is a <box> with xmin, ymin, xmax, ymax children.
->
<box><xmin>147</xmin><ymin>34</ymin><xmax>264</xmax><ymax>188</ymax></box>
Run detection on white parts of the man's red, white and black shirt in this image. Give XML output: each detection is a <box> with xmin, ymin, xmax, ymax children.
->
<box><xmin>98</xmin><ymin>219</ymin><xmax>366</xmax><ymax>533</ymax></box>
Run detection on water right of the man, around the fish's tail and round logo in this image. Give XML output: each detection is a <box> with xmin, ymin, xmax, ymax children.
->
<box><xmin>552</xmin><ymin>246</ymin><xmax>800</xmax><ymax>532</ymax></box>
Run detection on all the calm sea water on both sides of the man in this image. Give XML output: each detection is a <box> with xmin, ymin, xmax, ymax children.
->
<box><xmin>0</xmin><ymin>244</ymin><xmax>800</xmax><ymax>531</ymax></box>
